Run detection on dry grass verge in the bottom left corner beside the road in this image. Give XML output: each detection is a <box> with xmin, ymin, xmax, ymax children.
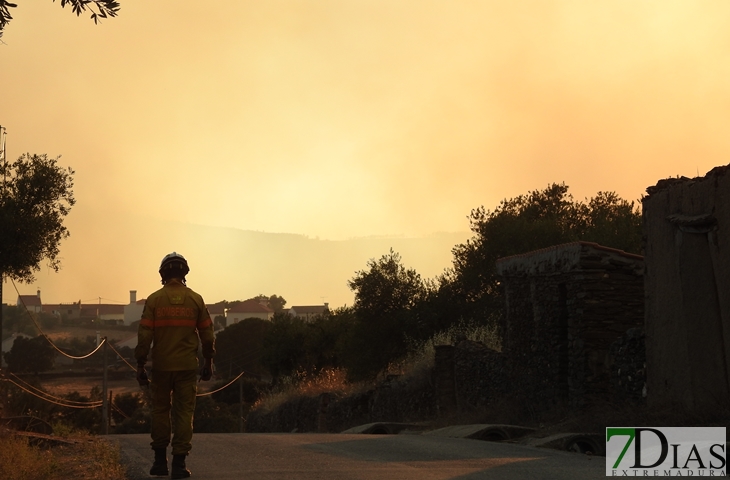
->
<box><xmin>0</xmin><ymin>430</ymin><xmax>126</xmax><ymax>480</ymax></box>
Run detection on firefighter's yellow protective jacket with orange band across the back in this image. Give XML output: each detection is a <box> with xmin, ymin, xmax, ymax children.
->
<box><xmin>134</xmin><ymin>280</ymin><xmax>215</xmax><ymax>371</ymax></box>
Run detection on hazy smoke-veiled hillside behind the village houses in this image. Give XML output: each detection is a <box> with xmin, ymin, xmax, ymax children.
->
<box><xmin>18</xmin><ymin>211</ymin><xmax>470</xmax><ymax>306</ymax></box>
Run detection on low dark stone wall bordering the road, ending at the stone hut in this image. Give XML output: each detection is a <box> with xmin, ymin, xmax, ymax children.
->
<box><xmin>246</xmin><ymin>340</ymin><xmax>512</xmax><ymax>432</ymax></box>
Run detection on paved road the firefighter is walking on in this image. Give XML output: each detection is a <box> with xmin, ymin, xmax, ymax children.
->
<box><xmin>106</xmin><ymin>433</ymin><xmax>605</xmax><ymax>480</ymax></box>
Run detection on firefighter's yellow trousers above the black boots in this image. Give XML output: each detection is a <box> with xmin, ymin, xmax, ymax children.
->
<box><xmin>150</xmin><ymin>370</ymin><xmax>198</xmax><ymax>455</ymax></box>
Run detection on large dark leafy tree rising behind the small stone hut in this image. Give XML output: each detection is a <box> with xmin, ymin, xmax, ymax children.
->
<box><xmin>435</xmin><ymin>184</ymin><xmax>642</xmax><ymax>332</ymax></box>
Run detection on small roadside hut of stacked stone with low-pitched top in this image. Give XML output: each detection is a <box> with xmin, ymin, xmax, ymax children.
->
<box><xmin>497</xmin><ymin>242</ymin><xmax>644</xmax><ymax>410</ymax></box>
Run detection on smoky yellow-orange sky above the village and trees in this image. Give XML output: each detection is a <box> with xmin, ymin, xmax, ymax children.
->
<box><xmin>0</xmin><ymin>0</ymin><xmax>730</xmax><ymax>306</ymax></box>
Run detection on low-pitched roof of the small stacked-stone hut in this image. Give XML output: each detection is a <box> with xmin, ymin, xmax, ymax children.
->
<box><xmin>496</xmin><ymin>241</ymin><xmax>644</xmax><ymax>276</ymax></box>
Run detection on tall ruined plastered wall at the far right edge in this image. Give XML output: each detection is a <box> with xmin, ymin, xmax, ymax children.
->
<box><xmin>643</xmin><ymin>165</ymin><xmax>730</xmax><ymax>412</ymax></box>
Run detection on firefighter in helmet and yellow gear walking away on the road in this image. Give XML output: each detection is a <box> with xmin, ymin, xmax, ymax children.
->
<box><xmin>134</xmin><ymin>252</ymin><xmax>215</xmax><ymax>479</ymax></box>
